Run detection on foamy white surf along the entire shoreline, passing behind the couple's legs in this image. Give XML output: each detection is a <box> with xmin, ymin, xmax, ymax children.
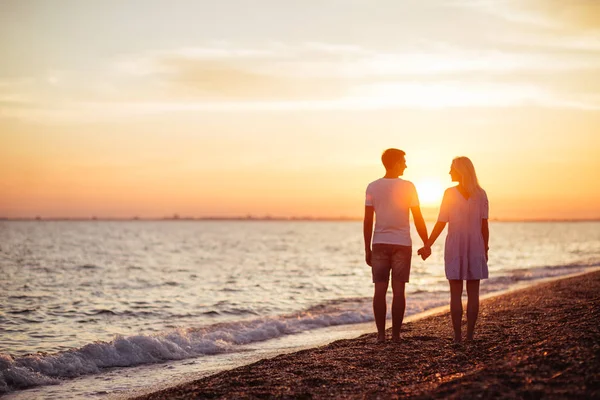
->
<box><xmin>0</xmin><ymin>263</ymin><xmax>600</xmax><ymax>394</ymax></box>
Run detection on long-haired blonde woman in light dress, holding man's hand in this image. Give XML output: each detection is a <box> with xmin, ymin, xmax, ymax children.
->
<box><xmin>419</xmin><ymin>157</ymin><xmax>489</xmax><ymax>343</ymax></box>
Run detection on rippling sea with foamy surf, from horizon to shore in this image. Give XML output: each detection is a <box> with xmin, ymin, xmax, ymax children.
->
<box><xmin>0</xmin><ymin>220</ymin><xmax>600</xmax><ymax>399</ymax></box>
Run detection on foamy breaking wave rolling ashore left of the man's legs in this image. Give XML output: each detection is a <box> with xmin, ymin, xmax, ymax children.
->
<box><xmin>0</xmin><ymin>303</ymin><xmax>373</xmax><ymax>393</ymax></box>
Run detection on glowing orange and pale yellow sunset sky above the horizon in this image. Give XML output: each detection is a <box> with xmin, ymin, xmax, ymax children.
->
<box><xmin>0</xmin><ymin>0</ymin><xmax>600</xmax><ymax>220</ymax></box>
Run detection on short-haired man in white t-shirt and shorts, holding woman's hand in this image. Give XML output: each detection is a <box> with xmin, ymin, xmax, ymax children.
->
<box><xmin>363</xmin><ymin>149</ymin><xmax>431</xmax><ymax>342</ymax></box>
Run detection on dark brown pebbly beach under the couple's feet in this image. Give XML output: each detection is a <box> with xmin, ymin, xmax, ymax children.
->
<box><xmin>132</xmin><ymin>271</ymin><xmax>600</xmax><ymax>400</ymax></box>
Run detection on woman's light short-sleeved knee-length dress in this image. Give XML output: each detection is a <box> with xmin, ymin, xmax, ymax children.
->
<box><xmin>438</xmin><ymin>186</ymin><xmax>489</xmax><ymax>280</ymax></box>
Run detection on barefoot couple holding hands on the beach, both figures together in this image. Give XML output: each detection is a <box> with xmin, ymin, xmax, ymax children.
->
<box><xmin>363</xmin><ymin>149</ymin><xmax>489</xmax><ymax>342</ymax></box>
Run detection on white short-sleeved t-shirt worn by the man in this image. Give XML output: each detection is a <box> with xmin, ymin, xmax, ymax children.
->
<box><xmin>365</xmin><ymin>178</ymin><xmax>419</xmax><ymax>246</ymax></box>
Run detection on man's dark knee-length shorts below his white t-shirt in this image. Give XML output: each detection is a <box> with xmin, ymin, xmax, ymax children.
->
<box><xmin>371</xmin><ymin>243</ymin><xmax>412</xmax><ymax>283</ymax></box>
